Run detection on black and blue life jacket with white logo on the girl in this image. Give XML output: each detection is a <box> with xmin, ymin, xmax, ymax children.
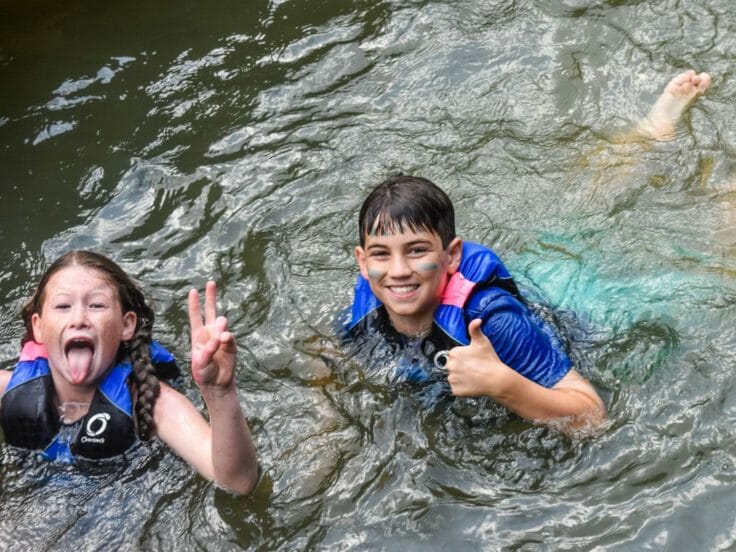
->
<box><xmin>0</xmin><ymin>341</ymin><xmax>176</xmax><ymax>463</ymax></box>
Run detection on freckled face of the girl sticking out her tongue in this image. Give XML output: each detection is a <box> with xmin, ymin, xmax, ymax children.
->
<box><xmin>31</xmin><ymin>265</ymin><xmax>137</xmax><ymax>386</ymax></box>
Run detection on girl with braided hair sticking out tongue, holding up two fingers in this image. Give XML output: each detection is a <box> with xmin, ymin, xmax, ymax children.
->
<box><xmin>0</xmin><ymin>251</ymin><xmax>258</xmax><ymax>494</ymax></box>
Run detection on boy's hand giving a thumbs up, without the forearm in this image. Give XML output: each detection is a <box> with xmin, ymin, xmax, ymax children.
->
<box><xmin>447</xmin><ymin>318</ymin><xmax>513</xmax><ymax>398</ymax></box>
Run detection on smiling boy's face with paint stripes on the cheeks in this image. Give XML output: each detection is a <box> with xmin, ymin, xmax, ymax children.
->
<box><xmin>355</xmin><ymin>225</ymin><xmax>462</xmax><ymax>335</ymax></box>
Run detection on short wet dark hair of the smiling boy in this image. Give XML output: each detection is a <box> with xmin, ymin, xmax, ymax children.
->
<box><xmin>358</xmin><ymin>175</ymin><xmax>455</xmax><ymax>248</ymax></box>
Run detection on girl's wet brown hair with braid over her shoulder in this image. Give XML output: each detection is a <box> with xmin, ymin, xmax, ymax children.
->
<box><xmin>21</xmin><ymin>251</ymin><xmax>160</xmax><ymax>441</ymax></box>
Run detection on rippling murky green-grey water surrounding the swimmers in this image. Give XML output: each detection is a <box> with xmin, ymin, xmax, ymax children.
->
<box><xmin>0</xmin><ymin>0</ymin><xmax>736</xmax><ymax>551</ymax></box>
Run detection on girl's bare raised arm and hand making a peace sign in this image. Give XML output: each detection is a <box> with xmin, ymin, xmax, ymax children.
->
<box><xmin>154</xmin><ymin>282</ymin><xmax>258</xmax><ymax>494</ymax></box>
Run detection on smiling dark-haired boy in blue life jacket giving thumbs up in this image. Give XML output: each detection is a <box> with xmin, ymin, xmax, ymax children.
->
<box><xmin>348</xmin><ymin>176</ymin><xmax>605</xmax><ymax>426</ymax></box>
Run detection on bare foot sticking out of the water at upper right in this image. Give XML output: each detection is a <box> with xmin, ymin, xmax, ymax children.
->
<box><xmin>639</xmin><ymin>69</ymin><xmax>711</xmax><ymax>140</ymax></box>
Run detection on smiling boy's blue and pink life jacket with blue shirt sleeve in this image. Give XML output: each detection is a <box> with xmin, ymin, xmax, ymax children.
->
<box><xmin>346</xmin><ymin>242</ymin><xmax>572</xmax><ymax>387</ymax></box>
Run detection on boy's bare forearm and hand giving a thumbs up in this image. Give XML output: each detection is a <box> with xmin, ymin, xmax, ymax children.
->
<box><xmin>447</xmin><ymin>319</ymin><xmax>605</xmax><ymax>428</ymax></box>
